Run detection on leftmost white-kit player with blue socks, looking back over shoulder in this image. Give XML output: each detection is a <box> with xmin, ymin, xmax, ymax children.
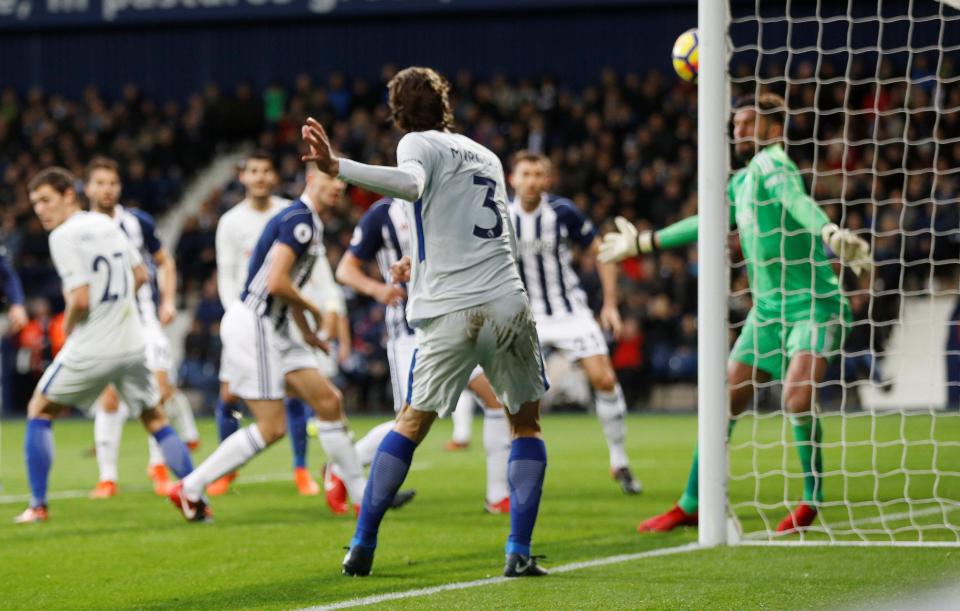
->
<box><xmin>16</xmin><ymin>168</ymin><xmax>193</xmax><ymax>523</ymax></box>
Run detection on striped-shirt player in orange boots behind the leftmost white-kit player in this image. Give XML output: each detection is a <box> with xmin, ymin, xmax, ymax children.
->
<box><xmin>84</xmin><ymin>157</ymin><xmax>200</xmax><ymax>499</ymax></box>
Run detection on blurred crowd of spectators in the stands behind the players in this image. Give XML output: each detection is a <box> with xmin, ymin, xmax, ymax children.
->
<box><xmin>0</xmin><ymin>60</ymin><xmax>960</xmax><ymax>414</ymax></box>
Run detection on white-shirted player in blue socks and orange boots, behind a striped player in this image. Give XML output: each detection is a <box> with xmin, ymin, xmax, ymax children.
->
<box><xmin>207</xmin><ymin>151</ymin><xmax>320</xmax><ymax>496</ymax></box>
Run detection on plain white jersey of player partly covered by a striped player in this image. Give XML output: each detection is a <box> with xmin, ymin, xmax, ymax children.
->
<box><xmin>217</xmin><ymin>196</ymin><xmax>290</xmax><ymax>309</ymax></box>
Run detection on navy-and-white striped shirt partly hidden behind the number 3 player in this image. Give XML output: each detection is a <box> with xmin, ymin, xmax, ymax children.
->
<box><xmin>350</xmin><ymin>197</ymin><xmax>413</xmax><ymax>340</ymax></box>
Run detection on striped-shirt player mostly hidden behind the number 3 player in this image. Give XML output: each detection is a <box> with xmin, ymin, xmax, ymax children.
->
<box><xmin>337</xmin><ymin>198</ymin><xmax>510</xmax><ymax>513</ymax></box>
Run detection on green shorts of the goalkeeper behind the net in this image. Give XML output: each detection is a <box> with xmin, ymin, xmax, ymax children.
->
<box><xmin>730</xmin><ymin>308</ymin><xmax>846</xmax><ymax>380</ymax></box>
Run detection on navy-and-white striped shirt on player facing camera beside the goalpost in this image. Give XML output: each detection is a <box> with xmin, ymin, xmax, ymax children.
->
<box><xmin>510</xmin><ymin>193</ymin><xmax>597</xmax><ymax>319</ymax></box>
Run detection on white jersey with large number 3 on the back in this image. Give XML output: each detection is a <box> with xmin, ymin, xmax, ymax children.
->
<box><xmin>397</xmin><ymin>131</ymin><xmax>523</xmax><ymax>326</ymax></box>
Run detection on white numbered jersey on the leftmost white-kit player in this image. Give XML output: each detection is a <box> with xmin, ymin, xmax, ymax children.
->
<box><xmin>50</xmin><ymin>211</ymin><xmax>145</xmax><ymax>365</ymax></box>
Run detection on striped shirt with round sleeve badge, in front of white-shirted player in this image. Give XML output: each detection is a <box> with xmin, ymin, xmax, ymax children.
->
<box><xmin>240</xmin><ymin>197</ymin><xmax>325</xmax><ymax>329</ymax></box>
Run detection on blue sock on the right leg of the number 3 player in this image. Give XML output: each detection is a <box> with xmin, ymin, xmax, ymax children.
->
<box><xmin>506</xmin><ymin>437</ymin><xmax>547</xmax><ymax>556</ymax></box>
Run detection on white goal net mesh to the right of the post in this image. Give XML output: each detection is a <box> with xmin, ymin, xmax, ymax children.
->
<box><xmin>729</xmin><ymin>0</ymin><xmax>960</xmax><ymax>545</ymax></box>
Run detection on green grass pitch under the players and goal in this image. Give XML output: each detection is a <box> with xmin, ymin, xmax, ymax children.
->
<box><xmin>0</xmin><ymin>415</ymin><xmax>960</xmax><ymax>609</ymax></box>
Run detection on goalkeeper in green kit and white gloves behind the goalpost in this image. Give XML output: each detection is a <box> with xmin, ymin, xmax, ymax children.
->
<box><xmin>600</xmin><ymin>94</ymin><xmax>871</xmax><ymax>532</ymax></box>
